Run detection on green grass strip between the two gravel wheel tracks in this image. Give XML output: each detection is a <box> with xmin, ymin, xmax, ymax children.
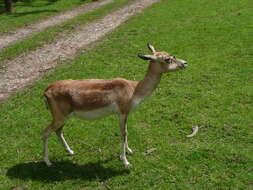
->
<box><xmin>0</xmin><ymin>0</ymin><xmax>132</xmax><ymax>61</ymax></box>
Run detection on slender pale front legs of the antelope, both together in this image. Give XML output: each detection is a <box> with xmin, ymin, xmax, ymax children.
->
<box><xmin>119</xmin><ymin>114</ymin><xmax>132</xmax><ymax>167</ymax></box>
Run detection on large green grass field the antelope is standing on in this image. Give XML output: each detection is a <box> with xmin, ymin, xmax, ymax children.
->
<box><xmin>0</xmin><ymin>0</ymin><xmax>253</xmax><ymax>190</ymax></box>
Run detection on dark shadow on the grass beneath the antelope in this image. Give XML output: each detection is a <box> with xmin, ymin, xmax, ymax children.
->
<box><xmin>7</xmin><ymin>160</ymin><xmax>129</xmax><ymax>182</ymax></box>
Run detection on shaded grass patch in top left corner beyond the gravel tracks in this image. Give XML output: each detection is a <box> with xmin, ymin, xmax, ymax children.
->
<box><xmin>0</xmin><ymin>0</ymin><xmax>91</xmax><ymax>34</ymax></box>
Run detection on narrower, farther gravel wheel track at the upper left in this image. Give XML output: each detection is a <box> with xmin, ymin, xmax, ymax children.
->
<box><xmin>0</xmin><ymin>0</ymin><xmax>113</xmax><ymax>50</ymax></box>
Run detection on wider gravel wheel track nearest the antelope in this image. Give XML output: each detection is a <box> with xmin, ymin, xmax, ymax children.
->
<box><xmin>0</xmin><ymin>0</ymin><xmax>158</xmax><ymax>100</ymax></box>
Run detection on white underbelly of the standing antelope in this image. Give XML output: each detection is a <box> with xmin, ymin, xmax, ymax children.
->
<box><xmin>73</xmin><ymin>104</ymin><xmax>118</xmax><ymax>120</ymax></box>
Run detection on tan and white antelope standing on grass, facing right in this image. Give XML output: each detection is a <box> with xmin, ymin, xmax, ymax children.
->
<box><xmin>43</xmin><ymin>44</ymin><xmax>187</xmax><ymax>167</ymax></box>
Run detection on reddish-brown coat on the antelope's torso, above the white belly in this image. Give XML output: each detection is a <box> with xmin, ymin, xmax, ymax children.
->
<box><xmin>44</xmin><ymin>78</ymin><xmax>137</xmax><ymax>114</ymax></box>
